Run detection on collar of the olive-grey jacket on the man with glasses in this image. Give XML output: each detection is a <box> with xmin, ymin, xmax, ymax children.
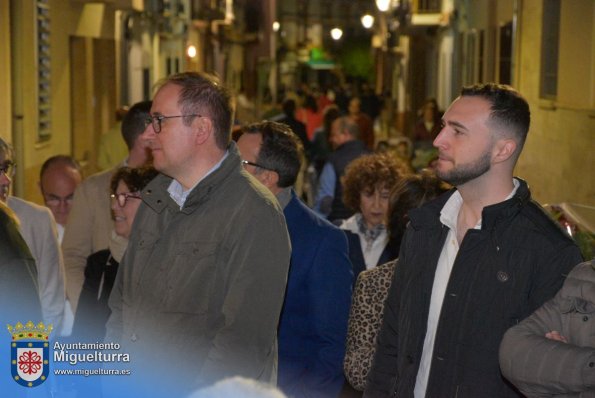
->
<box><xmin>141</xmin><ymin>142</ymin><xmax>242</xmax><ymax>214</ymax></box>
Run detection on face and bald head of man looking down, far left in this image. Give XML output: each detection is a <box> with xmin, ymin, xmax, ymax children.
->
<box><xmin>39</xmin><ymin>164</ymin><xmax>81</xmax><ymax>225</ymax></box>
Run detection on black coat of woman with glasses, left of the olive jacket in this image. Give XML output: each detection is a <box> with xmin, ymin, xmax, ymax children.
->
<box><xmin>72</xmin><ymin>249</ymin><xmax>119</xmax><ymax>342</ymax></box>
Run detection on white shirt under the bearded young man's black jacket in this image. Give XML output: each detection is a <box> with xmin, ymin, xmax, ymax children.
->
<box><xmin>413</xmin><ymin>179</ymin><xmax>520</xmax><ymax>398</ymax></box>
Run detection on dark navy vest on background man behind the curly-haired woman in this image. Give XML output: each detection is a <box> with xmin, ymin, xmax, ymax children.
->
<box><xmin>328</xmin><ymin>140</ymin><xmax>369</xmax><ymax>221</ymax></box>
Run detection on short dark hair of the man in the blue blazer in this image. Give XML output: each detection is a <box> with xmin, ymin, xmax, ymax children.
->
<box><xmin>242</xmin><ymin>121</ymin><xmax>304</xmax><ymax>188</ymax></box>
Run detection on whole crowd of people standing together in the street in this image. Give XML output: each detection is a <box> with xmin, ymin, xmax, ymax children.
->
<box><xmin>0</xmin><ymin>72</ymin><xmax>595</xmax><ymax>398</ymax></box>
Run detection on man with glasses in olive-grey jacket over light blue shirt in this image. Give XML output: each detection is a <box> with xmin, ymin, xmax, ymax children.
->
<box><xmin>106</xmin><ymin>72</ymin><xmax>290</xmax><ymax>396</ymax></box>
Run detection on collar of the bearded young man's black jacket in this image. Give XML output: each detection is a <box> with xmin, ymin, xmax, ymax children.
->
<box><xmin>410</xmin><ymin>177</ymin><xmax>531</xmax><ymax>230</ymax></box>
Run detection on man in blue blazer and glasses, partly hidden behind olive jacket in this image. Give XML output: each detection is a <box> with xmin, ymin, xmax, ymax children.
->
<box><xmin>238</xmin><ymin>122</ymin><xmax>353</xmax><ymax>397</ymax></box>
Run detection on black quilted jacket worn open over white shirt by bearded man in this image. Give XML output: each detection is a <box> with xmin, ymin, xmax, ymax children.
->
<box><xmin>365</xmin><ymin>180</ymin><xmax>581</xmax><ymax>398</ymax></box>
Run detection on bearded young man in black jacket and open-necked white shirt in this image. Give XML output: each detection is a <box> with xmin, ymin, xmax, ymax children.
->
<box><xmin>365</xmin><ymin>84</ymin><xmax>581</xmax><ymax>398</ymax></box>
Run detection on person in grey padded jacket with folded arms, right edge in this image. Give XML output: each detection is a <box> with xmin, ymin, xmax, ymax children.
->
<box><xmin>500</xmin><ymin>260</ymin><xmax>595</xmax><ymax>398</ymax></box>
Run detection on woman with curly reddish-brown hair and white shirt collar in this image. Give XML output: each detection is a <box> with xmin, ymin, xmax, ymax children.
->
<box><xmin>340</xmin><ymin>154</ymin><xmax>401</xmax><ymax>278</ymax></box>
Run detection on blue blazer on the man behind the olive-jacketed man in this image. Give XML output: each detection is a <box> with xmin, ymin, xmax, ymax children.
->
<box><xmin>277</xmin><ymin>192</ymin><xmax>353</xmax><ymax>397</ymax></box>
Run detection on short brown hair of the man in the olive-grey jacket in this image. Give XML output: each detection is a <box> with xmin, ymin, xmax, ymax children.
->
<box><xmin>159</xmin><ymin>72</ymin><xmax>234</xmax><ymax>149</ymax></box>
